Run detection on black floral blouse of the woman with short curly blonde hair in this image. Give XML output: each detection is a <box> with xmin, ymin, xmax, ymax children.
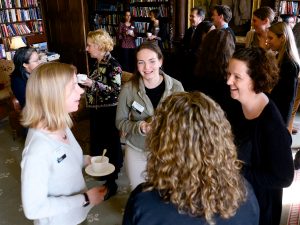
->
<box><xmin>86</xmin><ymin>52</ymin><xmax>122</xmax><ymax>108</ymax></box>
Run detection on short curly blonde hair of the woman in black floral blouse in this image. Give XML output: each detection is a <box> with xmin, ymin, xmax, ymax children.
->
<box><xmin>87</xmin><ymin>29</ymin><xmax>114</xmax><ymax>52</ymax></box>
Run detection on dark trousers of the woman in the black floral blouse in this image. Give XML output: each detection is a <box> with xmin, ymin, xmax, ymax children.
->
<box><xmin>90</xmin><ymin>106</ymin><xmax>123</xmax><ymax>182</ymax></box>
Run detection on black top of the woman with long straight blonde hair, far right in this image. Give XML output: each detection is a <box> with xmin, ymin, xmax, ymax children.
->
<box><xmin>270</xmin><ymin>55</ymin><xmax>299</xmax><ymax>126</ymax></box>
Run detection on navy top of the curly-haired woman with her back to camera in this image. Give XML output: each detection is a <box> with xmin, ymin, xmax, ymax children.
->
<box><xmin>123</xmin><ymin>181</ymin><xmax>259</xmax><ymax>225</ymax></box>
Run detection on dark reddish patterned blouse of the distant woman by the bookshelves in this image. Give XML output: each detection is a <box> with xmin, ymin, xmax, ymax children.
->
<box><xmin>118</xmin><ymin>23</ymin><xmax>137</xmax><ymax>48</ymax></box>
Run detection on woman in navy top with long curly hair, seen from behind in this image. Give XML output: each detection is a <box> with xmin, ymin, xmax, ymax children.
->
<box><xmin>123</xmin><ymin>92</ymin><xmax>259</xmax><ymax>225</ymax></box>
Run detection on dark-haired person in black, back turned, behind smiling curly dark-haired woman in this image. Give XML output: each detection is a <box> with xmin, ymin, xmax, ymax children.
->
<box><xmin>193</xmin><ymin>29</ymin><xmax>248</xmax><ymax>147</ymax></box>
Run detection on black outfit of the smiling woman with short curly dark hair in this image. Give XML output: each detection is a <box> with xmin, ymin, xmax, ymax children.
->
<box><xmin>239</xmin><ymin>100</ymin><xmax>294</xmax><ymax>225</ymax></box>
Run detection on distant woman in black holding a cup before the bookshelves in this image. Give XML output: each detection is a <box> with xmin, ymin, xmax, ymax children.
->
<box><xmin>147</xmin><ymin>9</ymin><xmax>168</xmax><ymax>50</ymax></box>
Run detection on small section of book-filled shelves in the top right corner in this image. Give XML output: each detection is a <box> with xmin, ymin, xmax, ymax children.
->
<box><xmin>277</xmin><ymin>0</ymin><xmax>300</xmax><ymax>21</ymax></box>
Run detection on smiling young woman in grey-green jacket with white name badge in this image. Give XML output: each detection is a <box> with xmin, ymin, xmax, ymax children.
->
<box><xmin>116</xmin><ymin>42</ymin><xmax>183</xmax><ymax>189</ymax></box>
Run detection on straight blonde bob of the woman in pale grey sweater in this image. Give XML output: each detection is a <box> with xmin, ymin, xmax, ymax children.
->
<box><xmin>21</xmin><ymin>62</ymin><xmax>77</xmax><ymax>131</ymax></box>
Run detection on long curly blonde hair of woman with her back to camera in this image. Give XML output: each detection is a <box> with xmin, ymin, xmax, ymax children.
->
<box><xmin>145</xmin><ymin>92</ymin><xmax>247</xmax><ymax>224</ymax></box>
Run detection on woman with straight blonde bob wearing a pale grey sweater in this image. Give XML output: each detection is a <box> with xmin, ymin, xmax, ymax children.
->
<box><xmin>21</xmin><ymin>62</ymin><xmax>106</xmax><ymax>225</ymax></box>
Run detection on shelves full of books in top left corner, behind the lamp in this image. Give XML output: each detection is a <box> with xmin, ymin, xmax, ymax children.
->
<box><xmin>0</xmin><ymin>0</ymin><xmax>46</xmax><ymax>59</ymax></box>
